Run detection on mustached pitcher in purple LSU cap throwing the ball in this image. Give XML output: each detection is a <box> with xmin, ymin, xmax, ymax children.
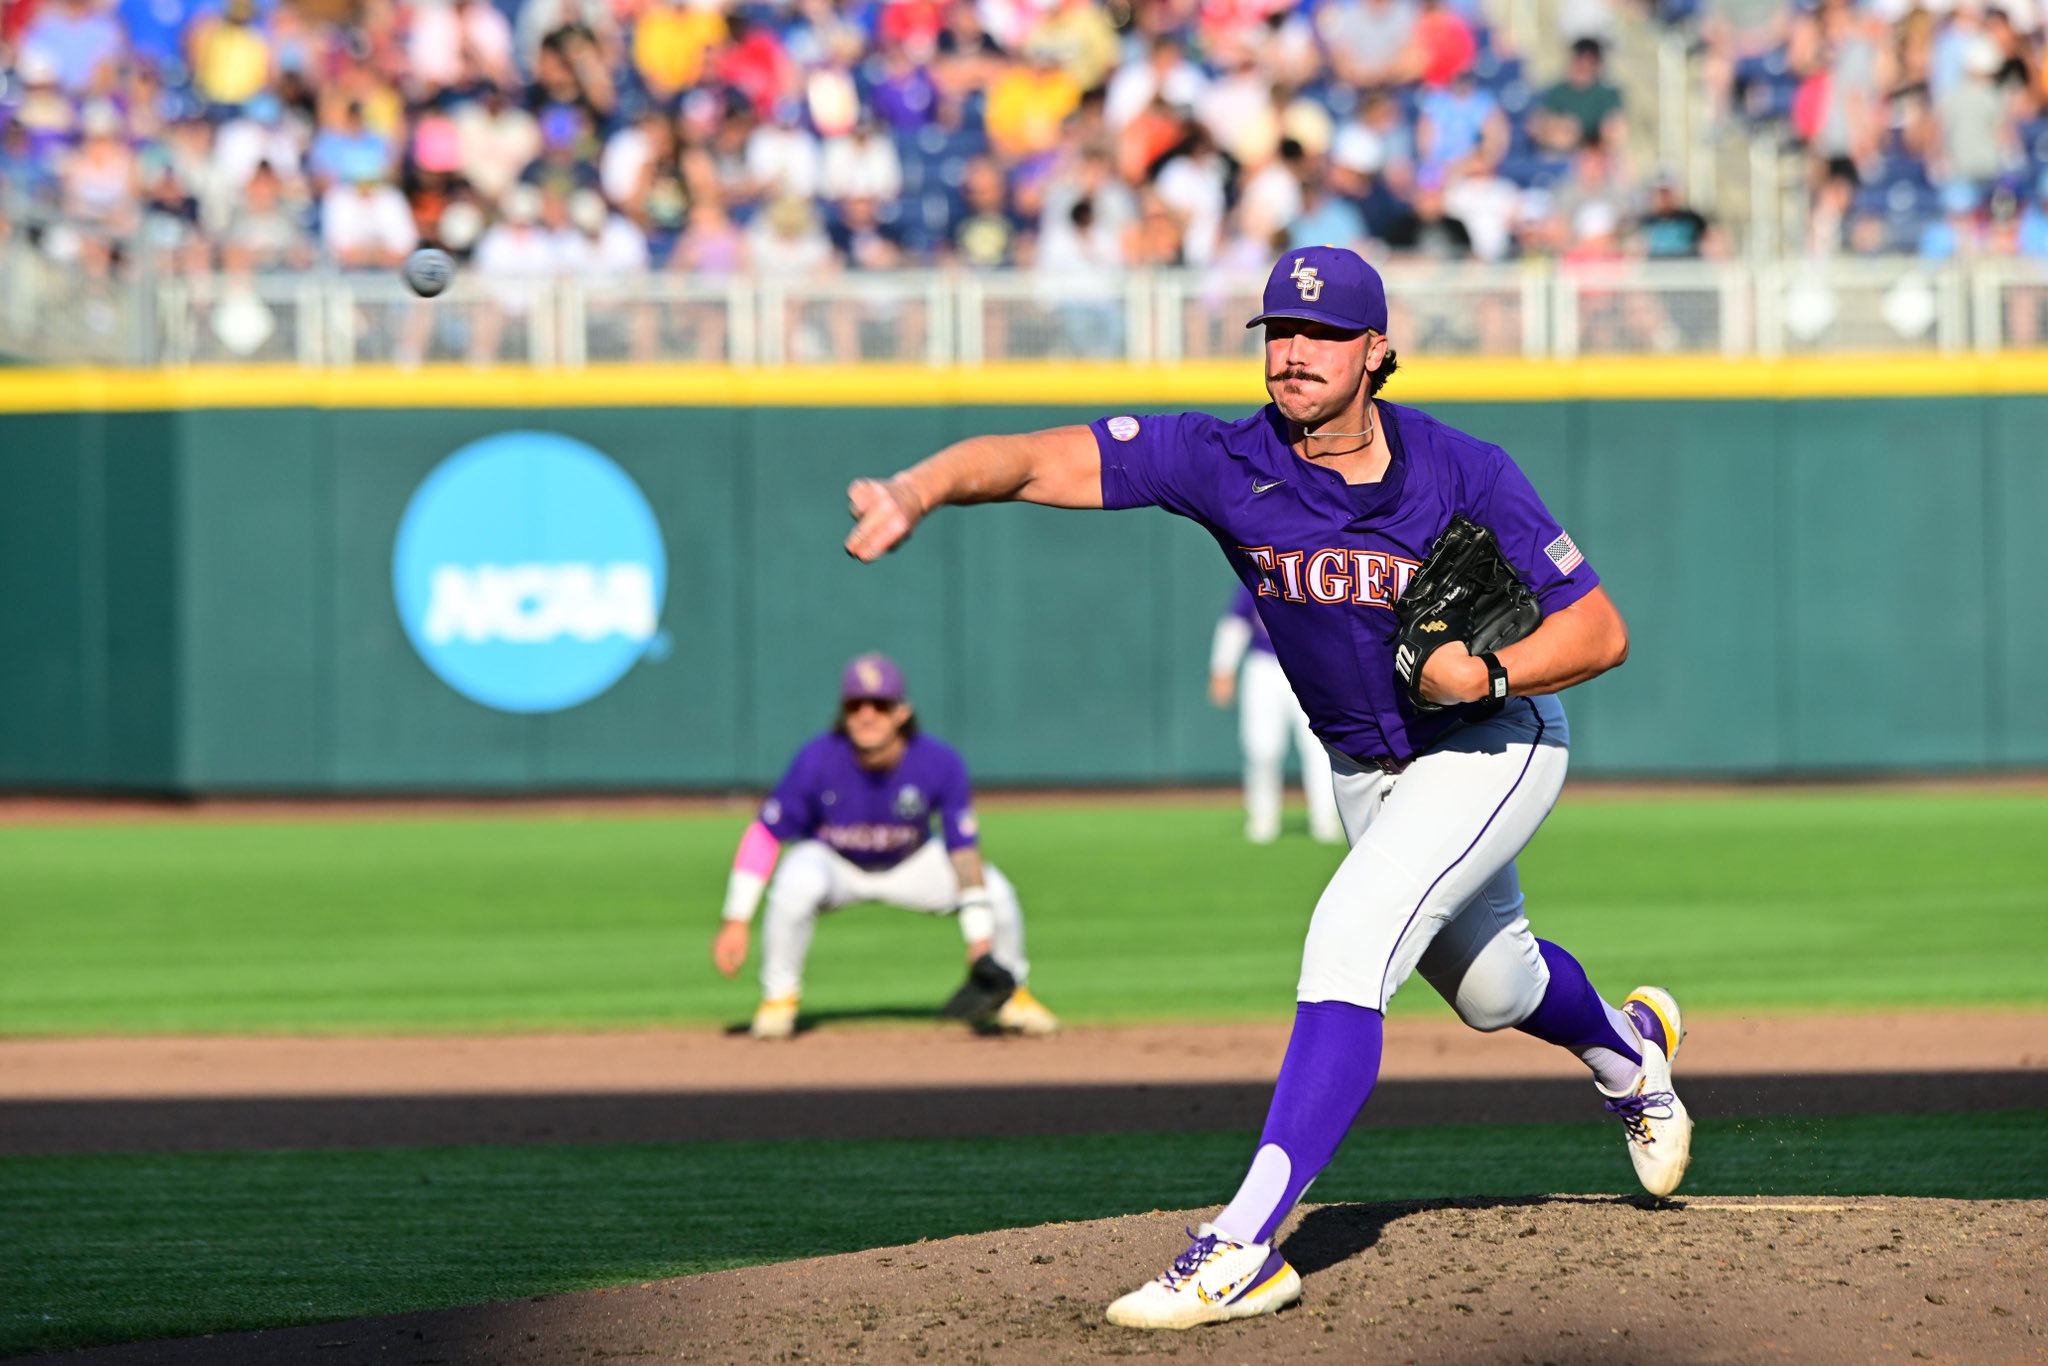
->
<box><xmin>846</xmin><ymin>246</ymin><xmax>1692</xmax><ymax>1329</ymax></box>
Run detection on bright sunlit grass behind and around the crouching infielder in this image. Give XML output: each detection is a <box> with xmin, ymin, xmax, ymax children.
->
<box><xmin>0</xmin><ymin>793</ymin><xmax>2048</xmax><ymax>1034</ymax></box>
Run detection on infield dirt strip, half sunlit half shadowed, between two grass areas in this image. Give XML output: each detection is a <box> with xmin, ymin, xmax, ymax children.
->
<box><xmin>0</xmin><ymin>1014</ymin><xmax>2048</xmax><ymax>1153</ymax></box>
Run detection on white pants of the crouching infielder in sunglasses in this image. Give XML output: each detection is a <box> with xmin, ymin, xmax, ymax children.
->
<box><xmin>762</xmin><ymin>840</ymin><xmax>1030</xmax><ymax>999</ymax></box>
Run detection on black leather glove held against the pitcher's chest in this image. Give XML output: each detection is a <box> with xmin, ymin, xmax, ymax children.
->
<box><xmin>1395</xmin><ymin>516</ymin><xmax>1542</xmax><ymax>711</ymax></box>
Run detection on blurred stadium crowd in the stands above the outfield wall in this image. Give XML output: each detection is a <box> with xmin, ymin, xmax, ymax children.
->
<box><xmin>0</xmin><ymin>0</ymin><xmax>2048</xmax><ymax>279</ymax></box>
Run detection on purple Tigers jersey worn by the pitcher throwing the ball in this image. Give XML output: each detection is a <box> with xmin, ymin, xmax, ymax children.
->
<box><xmin>1094</xmin><ymin>401</ymin><xmax>1599</xmax><ymax>760</ymax></box>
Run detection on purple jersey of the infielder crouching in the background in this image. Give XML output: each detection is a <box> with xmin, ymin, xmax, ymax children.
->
<box><xmin>762</xmin><ymin>731</ymin><xmax>975</xmax><ymax>870</ymax></box>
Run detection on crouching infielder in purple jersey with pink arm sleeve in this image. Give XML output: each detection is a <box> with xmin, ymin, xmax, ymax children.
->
<box><xmin>711</xmin><ymin>655</ymin><xmax>1059</xmax><ymax>1038</ymax></box>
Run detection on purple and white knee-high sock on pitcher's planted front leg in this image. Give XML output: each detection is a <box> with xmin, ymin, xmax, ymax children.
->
<box><xmin>1217</xmin><ymin>1001</ymin><xmax>1382</xmax><ymax>1243</ymax></box>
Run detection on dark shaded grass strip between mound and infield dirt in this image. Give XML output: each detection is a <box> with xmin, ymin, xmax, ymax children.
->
<box><xmin>0</xmin><ymin>1114</ymin><xmax>2048</xmax><ymax>1356</ymax></box>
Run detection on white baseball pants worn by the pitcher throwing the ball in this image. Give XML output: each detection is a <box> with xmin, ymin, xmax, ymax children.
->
<box><xmin>1296</xmin><ymin>696</ymin><xmax>1571</xmax><ymax>1030</ymax></box>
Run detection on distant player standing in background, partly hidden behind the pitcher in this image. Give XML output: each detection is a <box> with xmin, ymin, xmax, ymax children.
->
<box><xmin>1208</xmin><ymin>584</ymin><xmax>1343</xmax><ymax>844</ymax></box>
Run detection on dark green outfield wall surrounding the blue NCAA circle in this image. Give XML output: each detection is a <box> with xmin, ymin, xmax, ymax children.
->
<box><xmin>0</xmin><ymin>367</ymin><xmax>2048</xmax><ymax>793</ymax></box>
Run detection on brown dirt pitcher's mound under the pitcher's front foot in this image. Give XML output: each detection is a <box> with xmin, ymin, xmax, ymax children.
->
<box><xmin>24</xmin><ymin>1196</ymin><xmax>2048</xmax><ymax>1366</ymax></box>
